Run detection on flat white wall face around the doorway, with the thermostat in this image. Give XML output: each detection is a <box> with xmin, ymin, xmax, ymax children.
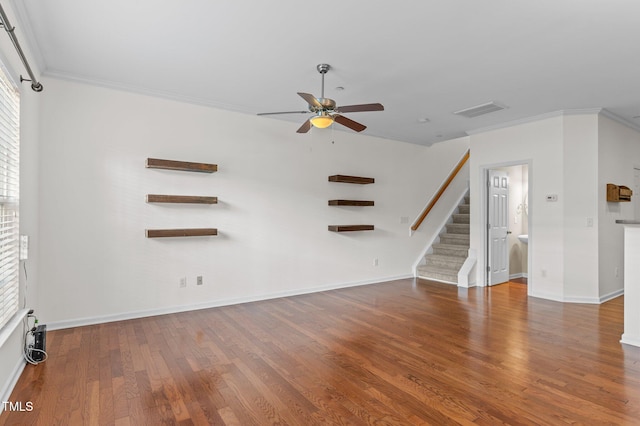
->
<box><xmin>470</xmin><ymin>116</ymin><xmax>564</xmax><ymax>300</ymax></box>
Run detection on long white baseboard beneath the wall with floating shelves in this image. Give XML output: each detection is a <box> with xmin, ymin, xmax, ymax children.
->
<box><xmin>47</xmin><ymin>274</ymin><xmax>414</xmax><ymax>330</ymax></box>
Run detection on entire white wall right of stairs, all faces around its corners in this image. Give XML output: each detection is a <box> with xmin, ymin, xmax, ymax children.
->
<box><xmin>470</xmin><ymin>110</ymin><xmax>640</xmax><ymax>303</ymax></box>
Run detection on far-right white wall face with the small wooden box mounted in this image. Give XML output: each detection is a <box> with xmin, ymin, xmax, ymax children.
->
<box><xmin>597</xmin><ymin>115</ymin><xmax>640</xmax><ymax>298</ymax></box>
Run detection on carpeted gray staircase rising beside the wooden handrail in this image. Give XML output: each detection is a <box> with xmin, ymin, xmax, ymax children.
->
<box><xmin>417</xmin><ymin>194</ymin><xmax>469</xmax><ymax>284</ymax></box>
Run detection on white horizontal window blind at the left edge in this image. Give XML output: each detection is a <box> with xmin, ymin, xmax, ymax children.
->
<box><xmin>0</xmin><ymin>63</ymin><xmax>20</xmax><ymax>329</ymax></box>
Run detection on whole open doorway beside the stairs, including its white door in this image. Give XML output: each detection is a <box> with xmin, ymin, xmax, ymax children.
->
<box><xmin>482</xmin><ymin>163</ymin><xmax>532</xmax><ymax>292</ymax></box>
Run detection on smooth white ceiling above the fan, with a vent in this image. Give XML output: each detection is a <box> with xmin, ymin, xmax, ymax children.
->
<box><xmin>12</xmin><ymin>0</ymin><xmax>640</xmax><ymax>145</ymax></box>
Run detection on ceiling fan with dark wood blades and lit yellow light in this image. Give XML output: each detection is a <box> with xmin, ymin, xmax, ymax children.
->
<box><xmin>258</xmin><ymin>64</ymin><xmax>384</xmax><ymax>133</ymax></box>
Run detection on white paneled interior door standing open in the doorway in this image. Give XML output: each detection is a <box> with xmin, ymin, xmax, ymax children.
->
<box><xmin>487</xmin><ymin>170</ymin><xmax>509</xmax><ymax>285</ymax></box>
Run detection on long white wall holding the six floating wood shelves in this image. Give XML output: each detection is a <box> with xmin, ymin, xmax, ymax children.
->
<box><xmin>39</xmin><ymin>79</ymin><xmax>468</xmax><ymax>328</ymax></box>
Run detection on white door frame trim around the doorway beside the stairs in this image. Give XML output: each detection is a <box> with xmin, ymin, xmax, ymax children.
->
<box><xmin>477</xmin><ymin>159</ymin><xmax>535</xmax><ymax>295</ymax></box>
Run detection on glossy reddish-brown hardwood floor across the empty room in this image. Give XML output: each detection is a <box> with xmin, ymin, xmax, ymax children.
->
<box><xmin>0</xmin><ymin>280</ymin><xmax>640</xmax><ymax>425</ymax></box>
